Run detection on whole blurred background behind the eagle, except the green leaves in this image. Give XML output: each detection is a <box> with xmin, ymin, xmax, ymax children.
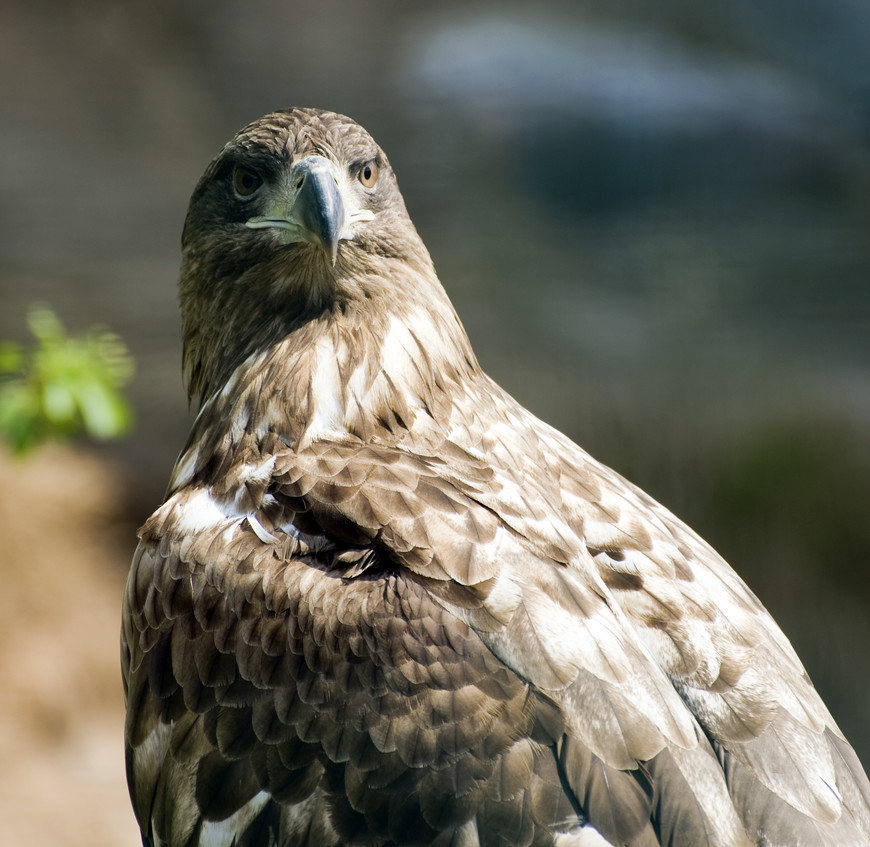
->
<box><xmin>0</xmin><ymin>0</ymin><xmax>870</xmax><ymax>847</ymax></box>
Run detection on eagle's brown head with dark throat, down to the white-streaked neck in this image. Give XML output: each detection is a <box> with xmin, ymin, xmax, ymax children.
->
<box><xmin>180</xmin><ymin>108</ymin><xmax>446</xmax><ymax>408</ymax></box>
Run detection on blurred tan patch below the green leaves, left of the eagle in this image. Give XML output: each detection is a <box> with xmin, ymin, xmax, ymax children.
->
<box><xmin>0</xmin><ymin>447</ymin><xmax>140</xmax><ymax>847</ymax></box>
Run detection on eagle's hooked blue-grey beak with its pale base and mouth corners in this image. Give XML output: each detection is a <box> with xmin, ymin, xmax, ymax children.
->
<box><xmin>245</xmin><ymin>156</ymin><xmax>374</xmax><ymax>265</ymax></box>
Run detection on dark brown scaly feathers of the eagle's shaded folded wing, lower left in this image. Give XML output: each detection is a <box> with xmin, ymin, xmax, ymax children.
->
<box><xmin>124</xmin><ymin>506</ymin><xmax>584</xmax><ymax>843</ymax></box>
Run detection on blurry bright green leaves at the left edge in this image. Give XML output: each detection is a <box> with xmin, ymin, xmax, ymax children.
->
<box><xmin>0</xmin><ymin>305</ymin><xmax>133</xmax><ymax>453</ymax></box>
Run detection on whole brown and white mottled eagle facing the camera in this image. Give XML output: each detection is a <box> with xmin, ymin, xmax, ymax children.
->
<box><xmin>122</xmin><ymin>109</ymin><xmax>870</xmax><ymax>847</ymax></box>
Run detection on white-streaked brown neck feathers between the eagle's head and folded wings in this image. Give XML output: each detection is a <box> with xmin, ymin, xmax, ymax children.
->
<box><xmin>171</xmin><ymin>288</ymin><xmax>480</xmax><ymax>490</ymax></box>
